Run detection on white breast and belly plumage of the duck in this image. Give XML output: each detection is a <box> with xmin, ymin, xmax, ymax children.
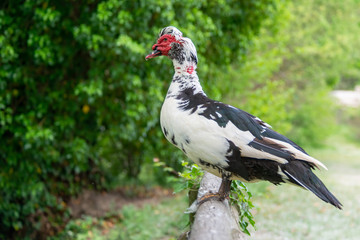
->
<box><xmin>160</xmin><ymin>98</ymin><xmax>243</xmax><ymax>167</ymax></box>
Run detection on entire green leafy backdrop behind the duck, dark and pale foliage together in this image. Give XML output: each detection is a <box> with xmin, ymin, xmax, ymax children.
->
<box><xmin>0</xmin><ymin>0</ymin><xmax>360</xmax><ymax>238</ymax></box>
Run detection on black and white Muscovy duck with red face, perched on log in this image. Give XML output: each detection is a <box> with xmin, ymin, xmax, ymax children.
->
<box><xmin>146</xmin><ymin>26</ymin><xmax>342</xmax><ymax>209</ymax></box>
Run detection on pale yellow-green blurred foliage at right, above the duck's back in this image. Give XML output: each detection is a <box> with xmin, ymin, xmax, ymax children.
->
<box><xmin>219</xmin><ymin>0</ymin><xmax>360</xmax><ymax>146</ymax></box>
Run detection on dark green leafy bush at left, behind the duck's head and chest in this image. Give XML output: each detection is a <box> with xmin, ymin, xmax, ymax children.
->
<box><xmin>0</xmin><ymin>0</ymin><xmax>279</xmax><ymax>238</ymax></box>
